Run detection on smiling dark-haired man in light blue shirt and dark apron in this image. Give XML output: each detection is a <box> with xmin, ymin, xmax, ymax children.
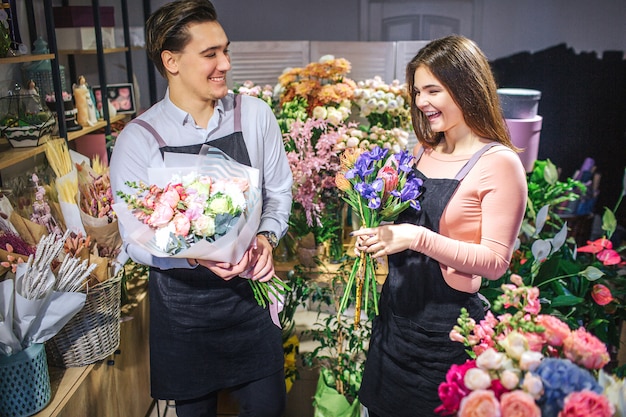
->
<box><xmin>110</xmin><ymin>0</ymin><xmax>292</xmax><ymax>417</ymax></box>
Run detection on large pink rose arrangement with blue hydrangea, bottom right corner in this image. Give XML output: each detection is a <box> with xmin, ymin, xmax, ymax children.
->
<box><xmin>435</xmin><ymin>275</ymin><xmax>624</xmax><ymax>417</ymax></box>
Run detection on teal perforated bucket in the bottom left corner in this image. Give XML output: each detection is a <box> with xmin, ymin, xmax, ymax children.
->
<box><xmin>0</xmin><ymin>343</ymin><xmax>50</xmax><ymax>417</ymax></box>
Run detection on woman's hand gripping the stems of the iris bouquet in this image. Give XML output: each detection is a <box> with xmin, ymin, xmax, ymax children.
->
<box><xmin>351</xmin><ymin>223</ymin><xmax>419</xmax><ymax>258</ymax></box>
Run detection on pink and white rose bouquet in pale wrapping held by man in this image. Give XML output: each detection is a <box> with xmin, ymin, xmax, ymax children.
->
<box><xmin>114</xmin><ymin>151</ymin><xmax>289</xmax><ymax>307</ymax></box>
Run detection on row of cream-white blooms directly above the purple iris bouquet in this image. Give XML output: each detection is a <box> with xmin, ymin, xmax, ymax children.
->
<box><xmin>337</xmin><ymin>126</ymin><xmax>409</xmax><ymax>153</ymax></box>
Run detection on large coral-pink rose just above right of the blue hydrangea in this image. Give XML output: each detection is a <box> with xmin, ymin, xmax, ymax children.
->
<box><xmin>563</xmin><ymin>327</ymin><xmax>610</xmax><ymax>369</ymax></box>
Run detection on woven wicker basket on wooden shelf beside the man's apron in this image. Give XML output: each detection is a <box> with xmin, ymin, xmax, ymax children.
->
<box><xmin>46</xmin><ymin>274</ymin><xmax>122</xmax><ymax>368</ymax></box>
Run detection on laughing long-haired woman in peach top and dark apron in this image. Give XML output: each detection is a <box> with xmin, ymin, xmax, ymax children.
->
<box><xmin>354</xmin><ymin>36</ymin><xmax>527</xmax><ymax>417</ymax></box>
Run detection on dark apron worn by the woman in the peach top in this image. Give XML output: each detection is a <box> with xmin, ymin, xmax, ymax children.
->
<box><xmin>359</xmin><ymin>142</ymin><xmax>497</xmax><ymax>417</ymax></box>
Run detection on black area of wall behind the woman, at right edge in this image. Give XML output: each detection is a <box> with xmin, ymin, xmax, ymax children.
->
<box><xmin>492</xmin><ymin>44</ymin><xmax>626</xmax><ymax>226</ymax></box>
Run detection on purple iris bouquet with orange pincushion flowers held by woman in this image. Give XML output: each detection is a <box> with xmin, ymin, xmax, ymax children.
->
<box><xmin>335</xmin><ymin>146</ymin><xmax>422</xmax><ymax>327</ymax></box>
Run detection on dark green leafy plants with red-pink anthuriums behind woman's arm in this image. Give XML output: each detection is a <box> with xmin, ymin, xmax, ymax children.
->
<box><xmin>480</xmin><ymin>160</ymin><xmax>626</xmax><ymax>364</ymax></box>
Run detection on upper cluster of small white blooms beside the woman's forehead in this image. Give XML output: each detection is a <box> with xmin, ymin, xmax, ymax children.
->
<box><xmin>353</xmin><ymin>76</ymin><xmax>409</xmax><ymax>117</ymax></box>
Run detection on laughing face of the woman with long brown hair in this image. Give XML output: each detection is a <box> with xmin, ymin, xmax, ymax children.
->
<box><xmin>414</xmin><ymin>66</ymin><xmax>465</xmax><ymax>132</ymax></box>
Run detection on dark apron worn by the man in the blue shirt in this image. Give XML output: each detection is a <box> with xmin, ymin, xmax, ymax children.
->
<box><xmin>133</xmin><ymin>95</ymin><xmax>284</xmax><ymax>400</ymax></box>
